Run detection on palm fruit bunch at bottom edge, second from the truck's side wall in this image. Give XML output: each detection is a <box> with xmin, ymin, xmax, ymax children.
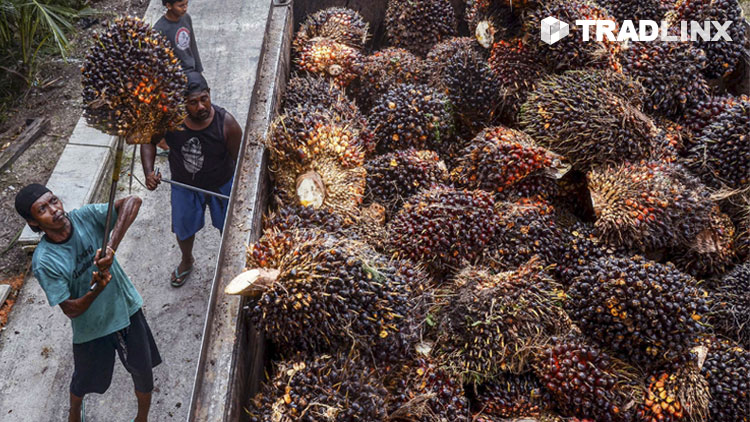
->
<box><xmin>386</xmin><ymin>357</ymin><xmax>471</xmax><ymax>422</ymax></box>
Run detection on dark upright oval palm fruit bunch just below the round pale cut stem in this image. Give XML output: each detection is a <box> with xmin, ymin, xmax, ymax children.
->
<box><xmin>427</xmin><ymin>37</ymin><xmax>506</xmax><ymax>133</ymax></box>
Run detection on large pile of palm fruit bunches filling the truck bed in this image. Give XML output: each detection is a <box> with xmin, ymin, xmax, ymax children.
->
<box><xmin>226</xmin><ymin>0</ymin><xmax>750</xmax><ymax>422</ymax></box>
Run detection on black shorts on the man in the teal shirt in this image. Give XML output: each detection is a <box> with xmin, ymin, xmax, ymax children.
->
<box><xmin>70</xmin><ymin>309</ymin><xmax>161</xmax><ymax>397</ymax></box>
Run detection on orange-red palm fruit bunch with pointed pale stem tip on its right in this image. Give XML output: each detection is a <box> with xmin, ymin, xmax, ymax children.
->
<box><xmin>451</xmin><ymin>126</ymin><xmax>570</xmax><ymax>193</ymax></box>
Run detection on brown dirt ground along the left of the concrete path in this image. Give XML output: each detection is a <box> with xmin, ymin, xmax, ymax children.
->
<box><xmin>0</xmin><ymin>0</ymin><xmax>148</xmax><ymax>326</ymax></box>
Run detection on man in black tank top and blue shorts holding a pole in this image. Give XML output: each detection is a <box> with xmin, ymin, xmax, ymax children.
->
<box><xmin>141</xmin><ymin>72</ymin><xmax>242</xmax><ymax>287</ymax></box>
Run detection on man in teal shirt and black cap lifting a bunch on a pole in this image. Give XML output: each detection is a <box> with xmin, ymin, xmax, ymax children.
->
<box><xmin>15</xmin><ymin>184</ymin><xmax>161</xmax><ymax>422</ymax></box>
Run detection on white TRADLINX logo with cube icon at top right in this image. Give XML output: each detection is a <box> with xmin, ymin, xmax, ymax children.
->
<box><xmin>541</xmin><ymin>16</ymin><xmax>732</xmax><ymax>45</ymax></box>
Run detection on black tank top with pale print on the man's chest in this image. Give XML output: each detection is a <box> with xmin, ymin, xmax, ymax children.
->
<box><xmin>165</xmin><ymin>104</ymin><xmax>234</xmax><ymax>190</ymax></box>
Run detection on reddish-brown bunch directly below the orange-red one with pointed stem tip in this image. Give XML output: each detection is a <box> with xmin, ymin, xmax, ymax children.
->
<box><xmin>481</xmin><ymin>198</ymin><xmax>563</xmax><ymax>271</ymax></box>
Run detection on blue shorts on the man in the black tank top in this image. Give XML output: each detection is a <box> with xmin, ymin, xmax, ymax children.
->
<box><xmin>172</xmin><ymin>179</ymin><xmax>232</xmax><ymax>241</ymax></box>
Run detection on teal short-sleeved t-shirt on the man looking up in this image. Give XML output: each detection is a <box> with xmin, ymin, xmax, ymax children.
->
<box><xmin>31</xmin><ymin>204</ymin><xmax>143</xmax><ymax>344</ymax></box>
